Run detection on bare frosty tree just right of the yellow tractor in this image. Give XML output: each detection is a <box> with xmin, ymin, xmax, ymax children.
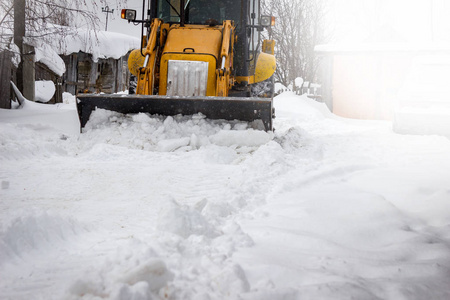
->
<box><xmin>263</xmin><ymin>0</ymin><xmax>326</xmax><ymax>86</ymax></box>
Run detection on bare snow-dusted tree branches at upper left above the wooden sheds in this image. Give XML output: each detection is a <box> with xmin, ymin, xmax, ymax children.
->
<box><xmin>0</xmin><ymin>0</ymin><xmax>127</xmax><ymax>96</ymax></box>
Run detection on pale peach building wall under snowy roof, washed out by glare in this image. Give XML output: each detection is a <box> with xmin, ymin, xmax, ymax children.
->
<box><xmin>322</xmin><ymin>52</ymin><xmax>414</xmax><ymax>120</ymax></box>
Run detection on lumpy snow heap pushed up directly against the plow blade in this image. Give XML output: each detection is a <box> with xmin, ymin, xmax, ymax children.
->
<box><xmin>83</xmin><ymin>109</ymin><xmax>273</xmax><ymax>152</ymax></box>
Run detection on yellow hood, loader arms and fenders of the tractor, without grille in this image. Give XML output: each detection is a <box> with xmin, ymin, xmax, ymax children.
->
<box><xmin>128</xmin><ymin>19</ymin><xmax>276</xmax><ymax>97</ymax></box>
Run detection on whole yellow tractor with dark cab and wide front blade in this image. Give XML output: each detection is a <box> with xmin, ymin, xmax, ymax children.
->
<box><xmin>77</xmin><ymin>0</ymin><xmax>276</xmax><ymax>131</ymax></box>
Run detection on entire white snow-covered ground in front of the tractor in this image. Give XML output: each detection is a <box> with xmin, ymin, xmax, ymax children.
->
<box><xmin>0</xmin><ymin>93</ymin><xmax>450</xmax><ymax>300</ymax></box>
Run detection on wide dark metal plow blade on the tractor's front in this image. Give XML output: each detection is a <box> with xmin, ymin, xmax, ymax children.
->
<box><xmin>77</xmin><ymin>94</ymin><xmax>273</xmax><ymax>131</ymax></box>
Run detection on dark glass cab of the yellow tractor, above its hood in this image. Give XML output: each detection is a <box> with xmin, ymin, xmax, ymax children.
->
<box><xmin>123</xmin><ymin>0</ymin><xmax>275</xmax><ymax>86</ymax></box>
